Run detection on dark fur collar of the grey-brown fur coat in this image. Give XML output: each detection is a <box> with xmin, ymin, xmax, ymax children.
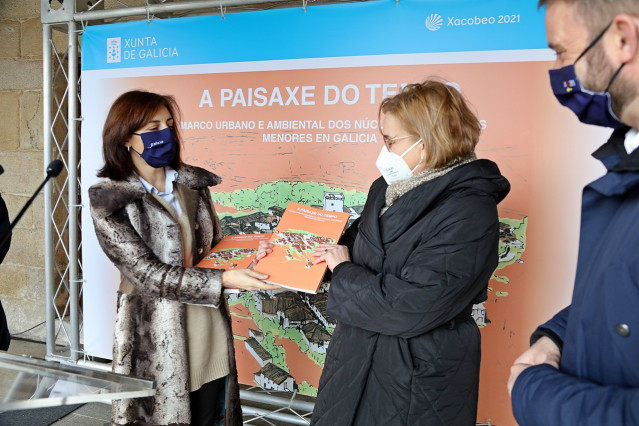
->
<box><xmin>89</xmin><ymin>164</ymin><xmax>222</xmax><ymax>218</ymax></box>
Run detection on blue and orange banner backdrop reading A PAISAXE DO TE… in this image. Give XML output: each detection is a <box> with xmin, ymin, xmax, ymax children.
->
<box><xmin>82</xmin><ymin>0</ymin><xmax>609</xmax><ymax>424</ymax></box>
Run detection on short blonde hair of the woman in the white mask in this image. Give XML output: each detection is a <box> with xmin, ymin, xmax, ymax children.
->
<box><xmin>378</xmin><ymin>80</ymin><xmax>481</xmax><ymax>169</ymax></box>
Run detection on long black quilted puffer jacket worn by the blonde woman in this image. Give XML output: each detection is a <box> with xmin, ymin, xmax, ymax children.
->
<box><xmin>312</xmin><ymin>160</ymin><xmax>510</xmax><ymax>426</ymax></box>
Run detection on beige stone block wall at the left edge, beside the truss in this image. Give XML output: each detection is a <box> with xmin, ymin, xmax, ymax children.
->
<box><xmin>0</xmin><ymin>0</ymin><xmax>45</xmax><ymax>340</ymax></box>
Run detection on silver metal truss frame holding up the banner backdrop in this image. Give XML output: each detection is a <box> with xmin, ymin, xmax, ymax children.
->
<box><xmin>41</xmin><ymin>0</ymin><xmax>376</xmax><ymax>425</ymax></box>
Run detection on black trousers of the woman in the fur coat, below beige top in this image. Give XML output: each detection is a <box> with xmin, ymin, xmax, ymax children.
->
<box><xmin>189</xmin><ymin>377</ymin><xmax>227</xmax><ymax>426</ymax></box>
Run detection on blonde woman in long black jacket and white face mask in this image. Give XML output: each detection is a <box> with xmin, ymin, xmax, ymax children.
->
<box><xmin>312</xmin><ymin>81</ymin><xmax>510</xmax><ymax>426</ymax></box>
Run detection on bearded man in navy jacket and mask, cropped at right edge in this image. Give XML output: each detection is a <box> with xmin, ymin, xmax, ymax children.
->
<box><xmin>508</xmin><ymin>0</ymin><xmax>639</xmax><ymax>426</ymax></box>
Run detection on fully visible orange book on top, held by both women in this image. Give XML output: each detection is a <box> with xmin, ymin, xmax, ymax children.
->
<box><xmin>255</xmin><ymin>203</ymin><xmax>350</xmax><ymax>293</ymax></box>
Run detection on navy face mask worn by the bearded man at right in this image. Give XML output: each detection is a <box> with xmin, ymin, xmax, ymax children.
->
<box><xmin>549</xmin><ymin>22</ymin><xmax>625</xmax><ymax>129</ymax></box>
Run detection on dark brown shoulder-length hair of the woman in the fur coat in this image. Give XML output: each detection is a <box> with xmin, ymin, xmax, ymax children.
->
<box><xmin>98</xmin><ymin>90</ymin><xmax>182</xmax><ymax>180</ymax></box>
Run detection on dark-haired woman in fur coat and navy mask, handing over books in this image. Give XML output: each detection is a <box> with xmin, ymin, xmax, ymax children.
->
<box><xmin>89</xmin><ymin>91</ymin><xmax>275</xmax><ymax>425</ymax></box>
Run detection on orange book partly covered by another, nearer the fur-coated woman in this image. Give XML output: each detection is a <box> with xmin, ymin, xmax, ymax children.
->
<box><xmin>197</xmin><ymin>233</ymin><xmax>272</xmax><ymax>271</ymax></box>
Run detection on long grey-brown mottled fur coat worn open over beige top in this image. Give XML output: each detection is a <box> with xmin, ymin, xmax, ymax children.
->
<box><xmin>89</xmin><ymin>165</ymin><xmax>242</xmax><ymax>425</ymax></box>
